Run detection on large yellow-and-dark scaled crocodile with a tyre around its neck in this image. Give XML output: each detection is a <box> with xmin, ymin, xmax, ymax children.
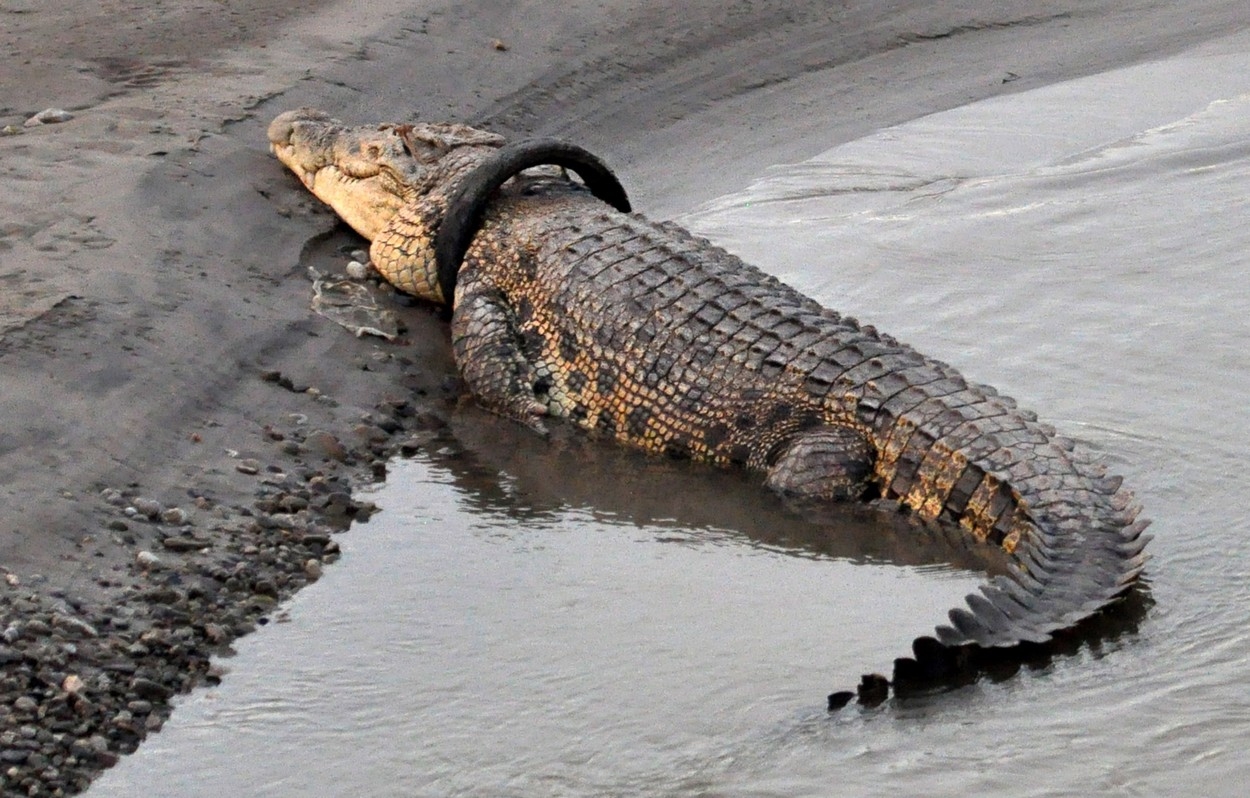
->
<box><xmin>269</xmin><ymin>109</ymin><xmax>1150</xmax><ymax>709</ymax></box>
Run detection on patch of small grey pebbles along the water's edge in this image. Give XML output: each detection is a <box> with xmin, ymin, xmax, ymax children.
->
<box><xmin>0</xmin><ymin>400</ymin><xmax>444</xmax><ymax>795</ymax></box>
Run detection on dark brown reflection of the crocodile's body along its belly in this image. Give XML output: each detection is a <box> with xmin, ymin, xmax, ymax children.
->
<box><xmin>434</xmin><ymin>408</ymin><xmax>1006</xmax><ymax>574</ymax></box>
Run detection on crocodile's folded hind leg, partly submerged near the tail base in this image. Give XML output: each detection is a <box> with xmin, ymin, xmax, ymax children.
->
<box><xmin>764</xmin><ymin>425</ymin><xmax>875</xmax><ymax>500</ymax></box>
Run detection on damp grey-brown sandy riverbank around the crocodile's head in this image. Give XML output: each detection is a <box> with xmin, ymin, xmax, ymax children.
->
<box><xmin>0</xmin><ymin>0</ymin><xmax>1250</xmax><ymax>794</ymax></box>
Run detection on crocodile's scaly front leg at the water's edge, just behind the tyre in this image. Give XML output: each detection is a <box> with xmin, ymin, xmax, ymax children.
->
<box><xmin>451</xmin><ymin>274</ymin><xmax>548</xmax><ymax>435</ymax></box>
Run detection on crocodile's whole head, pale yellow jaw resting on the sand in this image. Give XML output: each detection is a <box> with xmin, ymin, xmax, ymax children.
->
<box><xmin>269</xmin><ymin>108</ymin><xmax>504</xmax><ymax>241</ymax></box>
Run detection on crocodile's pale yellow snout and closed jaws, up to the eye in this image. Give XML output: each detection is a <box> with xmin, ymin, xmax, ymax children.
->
<box><xmin>269</xmin><ymin>108</ymin><xmax>424</xmax><ymax>241</ymax></box>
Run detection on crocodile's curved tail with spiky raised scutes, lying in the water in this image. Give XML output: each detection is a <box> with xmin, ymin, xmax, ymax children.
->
<box><xmin>831</xmin><ymin>360</ymin><xmax>1150</xmax><ymax>700</ymax></box>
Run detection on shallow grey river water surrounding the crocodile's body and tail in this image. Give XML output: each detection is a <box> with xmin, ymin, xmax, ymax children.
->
<box><xmin>91</xmin><ymin>39</ymin><xmax>1250</xmax><ymax>797</ymax></box>
